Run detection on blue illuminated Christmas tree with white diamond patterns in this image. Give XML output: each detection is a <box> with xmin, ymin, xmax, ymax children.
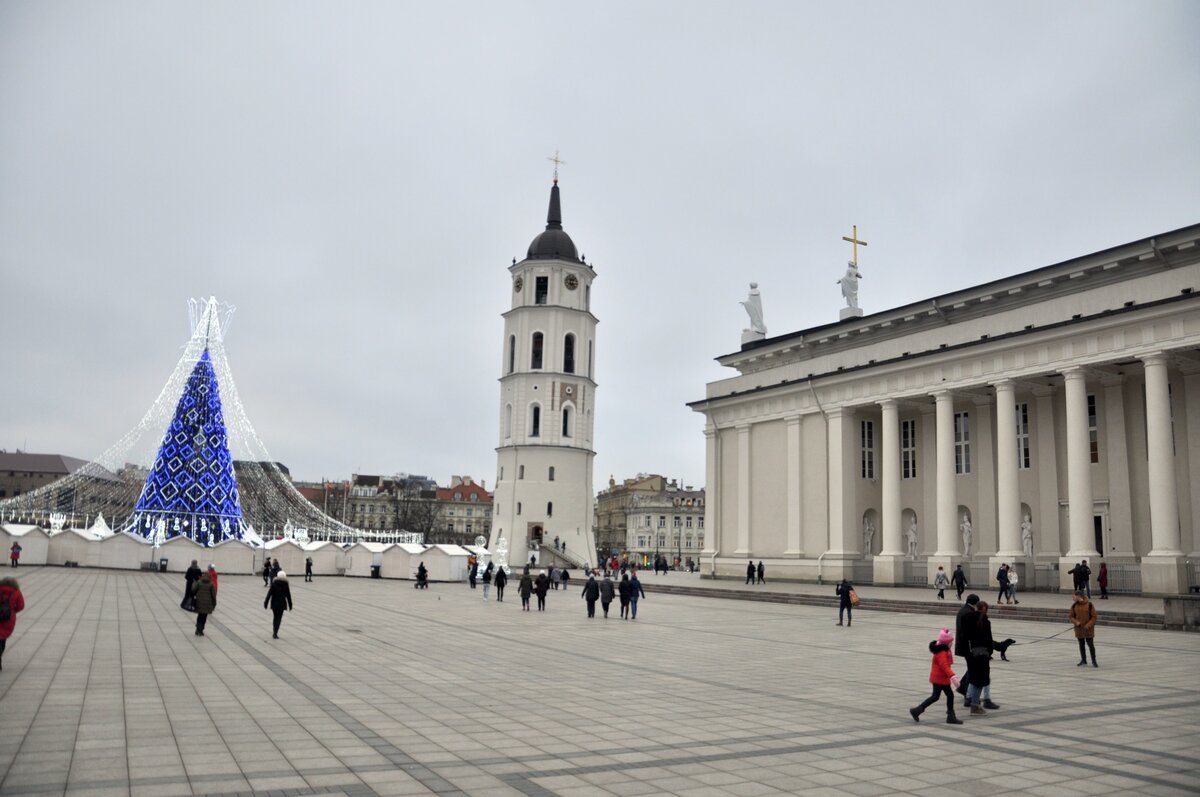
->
<box><xmin>134</xmin><ymin>349</ymin><xmax>241</xmax><ymax>545</ymax></box>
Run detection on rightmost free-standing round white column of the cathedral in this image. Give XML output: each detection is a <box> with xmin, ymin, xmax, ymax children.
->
<box><xmin>1141</xmin><ymin>352</ymin><xmax>1183</xmax><ymax>556</ymax></box>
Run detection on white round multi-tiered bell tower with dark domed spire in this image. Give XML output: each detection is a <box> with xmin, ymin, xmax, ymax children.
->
<box><xmin>488</xmin><ymin>173</ymin><xmax>598</xmax><ymax>573</ymax></box>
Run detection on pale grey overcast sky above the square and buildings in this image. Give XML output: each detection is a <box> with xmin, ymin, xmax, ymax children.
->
<box><xmin>0</xmin><ymin>0</ymin><xmax>1200</xmax><ymax>487</ymax></box>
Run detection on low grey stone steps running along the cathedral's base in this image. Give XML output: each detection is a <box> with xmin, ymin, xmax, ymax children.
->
<box><xmin>642</xmin><ymin>581</ymin><xmax>1163</xmax><ymax>629</ymax></box>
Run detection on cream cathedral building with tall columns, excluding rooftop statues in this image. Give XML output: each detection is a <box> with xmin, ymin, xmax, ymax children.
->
<box><xmin>690</xmin><ymin>224</ymin><xmax>1200</xmax><ymax>594</ymax></box>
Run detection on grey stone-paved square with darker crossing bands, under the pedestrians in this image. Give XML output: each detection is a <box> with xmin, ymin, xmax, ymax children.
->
<box><xmin>0</xmin><ymin>568</ymin><xmax>1200</xmax><ymax>797</ymax></box>
